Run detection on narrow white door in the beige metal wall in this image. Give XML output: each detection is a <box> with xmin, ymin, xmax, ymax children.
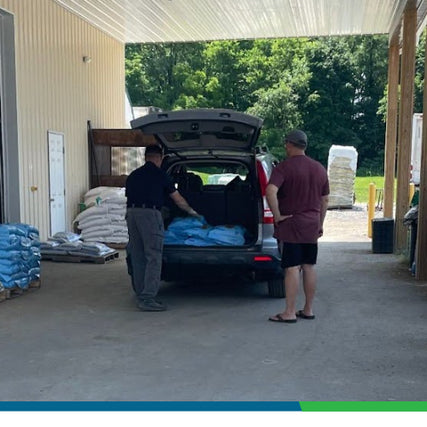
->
<box><xmin>48</xmin><ymin>132</ymin><xmax>67</xmax><ymax>236</ymax></box>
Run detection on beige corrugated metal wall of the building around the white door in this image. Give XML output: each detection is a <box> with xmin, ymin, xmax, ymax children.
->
<box><xmin>0</xmin><ymin>0</ymin><xmax>125</xmax><ymax>238</ymax></box>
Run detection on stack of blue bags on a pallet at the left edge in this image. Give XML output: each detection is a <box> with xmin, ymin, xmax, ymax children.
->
<box><xmin>0</xmin><ymin>224</ymin><xmax>41</xmax><ymax>289</ymax></box>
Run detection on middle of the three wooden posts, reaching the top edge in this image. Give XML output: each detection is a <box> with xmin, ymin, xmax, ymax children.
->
<box><xmin>395</xmin><ymin>0</ymin><xmax>417</xmax><ymax>253</ymax></box>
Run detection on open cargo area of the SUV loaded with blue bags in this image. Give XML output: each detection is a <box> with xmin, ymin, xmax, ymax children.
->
<box><xmin>163</xmin><ymin>161</ymin><xmax>260</xmax><ymax>246</ymax></box>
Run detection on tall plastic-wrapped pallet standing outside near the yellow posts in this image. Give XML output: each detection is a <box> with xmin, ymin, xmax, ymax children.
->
<box><xmin>328</xmin><ymin>145</ymin><xmax>357</xmax><ymax>208</ymax></box>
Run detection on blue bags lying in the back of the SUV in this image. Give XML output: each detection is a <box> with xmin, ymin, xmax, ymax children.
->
<box><xmin>164</xmin><ymin>217</ymin><xmax>246</xmax><ymax>246</ymax></box>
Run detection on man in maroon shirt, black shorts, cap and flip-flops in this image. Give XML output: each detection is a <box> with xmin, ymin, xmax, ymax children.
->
<box><xmin>266</xmin><ymin>130</ymin><xmax>329</xmax><ymax>323</ymax></box>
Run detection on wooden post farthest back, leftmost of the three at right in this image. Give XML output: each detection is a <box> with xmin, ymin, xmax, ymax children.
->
<box><xmin>383</xmin><ymin>33</ymin><xmax>399</xmax><ymax>218</ymax></box>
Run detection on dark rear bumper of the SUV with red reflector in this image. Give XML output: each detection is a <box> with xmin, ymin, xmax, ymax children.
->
<box><xmin>162</xmin><ymin>248</ymin><xmax>283</xmax><ymax>281</ymax></box>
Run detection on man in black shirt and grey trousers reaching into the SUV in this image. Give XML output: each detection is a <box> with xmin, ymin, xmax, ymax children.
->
<box><xmin>126</xmin><ymin>145</ymin><xmax>199</xmax><ymax>311</ymax></box>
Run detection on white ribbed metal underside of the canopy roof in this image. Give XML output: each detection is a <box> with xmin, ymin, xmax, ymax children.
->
<box><xmin>56</xmin><ymin>0</ymin><xmax>425</xmax><ymax>43</ymax></box>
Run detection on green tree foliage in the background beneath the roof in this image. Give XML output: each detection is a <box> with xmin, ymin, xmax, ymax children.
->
<box><xmin>126</xmin><ymin>36</ymin><xmax>425</xmax><ymax>173</ymax></box>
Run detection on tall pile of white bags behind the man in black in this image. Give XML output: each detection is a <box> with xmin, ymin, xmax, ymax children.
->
<box><xmin>74</xmin><ymin>187</ymin><xmax>129</xmax><ymax>245</ymax></box>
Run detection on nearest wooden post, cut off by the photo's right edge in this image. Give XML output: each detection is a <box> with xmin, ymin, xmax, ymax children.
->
<box><xmin>415</xmin><ymin>33</ymin><xmax>427</xmax><ymax>280</ymax></box>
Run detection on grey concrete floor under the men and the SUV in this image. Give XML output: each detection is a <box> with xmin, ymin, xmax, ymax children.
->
<box><xmin>0</xmin><ymin>227</ymin><xmax>427</xmax><ymax>401</ymax></box>
